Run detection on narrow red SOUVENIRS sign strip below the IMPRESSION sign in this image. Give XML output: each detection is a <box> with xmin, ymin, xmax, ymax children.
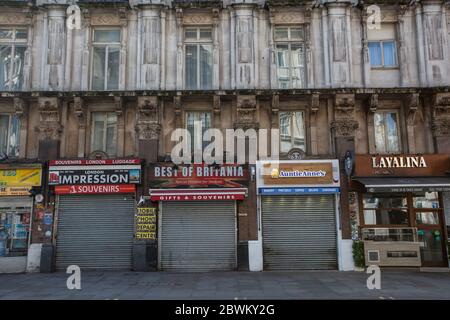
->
<box><xmin>55</xmin><ymin>184</ymin><xmax>136</xmax><ymax>194</ymax></box>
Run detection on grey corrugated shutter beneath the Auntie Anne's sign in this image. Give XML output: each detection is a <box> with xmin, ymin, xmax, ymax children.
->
<box><xmin>262</xmin><ymin>195</ymin><xmax>337</xmax><ymax>270</ymax></box>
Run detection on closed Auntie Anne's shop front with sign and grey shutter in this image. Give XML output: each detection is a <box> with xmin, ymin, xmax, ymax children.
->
<box><xmin>256</xmin><ymin>160</ymin><xmax>340</xmax><ymax>271</ymax></box>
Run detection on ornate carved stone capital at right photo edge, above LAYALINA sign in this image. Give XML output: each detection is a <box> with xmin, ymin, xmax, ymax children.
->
<box><xmin>431</xmin><ymin>93</ymin><xmax>450</xmax><ymax>137</ymax></box>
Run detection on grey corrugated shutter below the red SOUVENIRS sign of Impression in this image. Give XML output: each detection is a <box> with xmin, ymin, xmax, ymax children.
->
<box><xmin>56</xmin><ymin>195</ymin><xmax>135</xmax><ymax>270</ymax></box>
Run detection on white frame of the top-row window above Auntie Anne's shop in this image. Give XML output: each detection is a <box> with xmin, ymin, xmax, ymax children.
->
<box><xmin>273</xmin><ymin>25</ymin><xmax>307</xmax><ymax>89</ymax></box>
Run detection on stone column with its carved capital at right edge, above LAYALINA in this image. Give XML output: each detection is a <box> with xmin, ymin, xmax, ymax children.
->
<box><xmin>431</xmin><ymin>93</ymin><xmax>450</xmax><ymax>153</ymax></box>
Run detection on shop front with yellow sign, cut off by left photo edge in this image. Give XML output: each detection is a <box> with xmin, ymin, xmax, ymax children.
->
<box><xmin>0</xmin><ymin>164</ymin><xmax>42</xmax><ymax>273</ymax></box>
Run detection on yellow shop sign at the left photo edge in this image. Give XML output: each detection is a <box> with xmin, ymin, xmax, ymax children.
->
<box><xmin>0</xmin><ymin>168</ymin><xmax>42</xmax><ymax>187</ymax></box>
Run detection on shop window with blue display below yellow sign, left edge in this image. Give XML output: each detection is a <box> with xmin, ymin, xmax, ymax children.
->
<box><xmin>0</xmin><ymin>206</ymin><xmax>31</xmax><ymax>257</ymax></box>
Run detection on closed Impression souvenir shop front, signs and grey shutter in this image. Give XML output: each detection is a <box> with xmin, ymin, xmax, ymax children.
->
<box><xmin>49</xmin><ymin>159</ymin><xmax>141</xmax><ymax>270</ymax></box>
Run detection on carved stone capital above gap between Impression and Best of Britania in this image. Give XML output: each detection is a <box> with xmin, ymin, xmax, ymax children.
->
<box><xmin>136</xmin><ymin>96</ymin><xmax>161</xmax><ymax>140</ymax></box>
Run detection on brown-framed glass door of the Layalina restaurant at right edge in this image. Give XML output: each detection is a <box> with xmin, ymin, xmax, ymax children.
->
<box><xmin>413</xmin><ymin>192</ymin><xmax>448</xmax><ymax>267</ymax></box>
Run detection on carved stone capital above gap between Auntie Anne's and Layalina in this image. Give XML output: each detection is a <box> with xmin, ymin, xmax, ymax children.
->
<box><xmin>331</xmin><ymin>94</ymin><xmax>359</xmax><ymax>137</ymax></box>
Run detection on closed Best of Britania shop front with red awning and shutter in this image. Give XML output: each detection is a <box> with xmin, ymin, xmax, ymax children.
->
<box><xmin>149</xmin><ymin>164</ymin><xmax>249</xmax><ymax>272</ymax></box>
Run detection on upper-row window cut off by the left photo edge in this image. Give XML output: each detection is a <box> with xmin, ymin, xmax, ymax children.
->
<box><xmin>0</xmin><ymin>28</ymin><xmax>28</xmax><ymax>91</ymax></box>
